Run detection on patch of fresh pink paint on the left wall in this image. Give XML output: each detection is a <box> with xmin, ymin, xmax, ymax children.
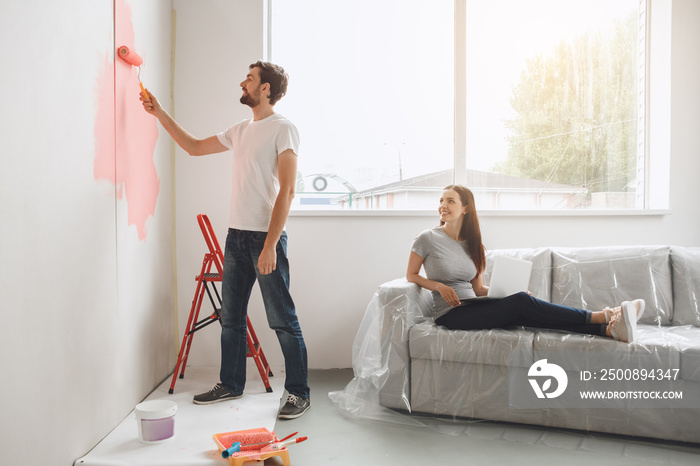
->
<box><xmin>94</xmin><ymin>0</ymin><xmax>160</xmax><ymax>241</ymax></box>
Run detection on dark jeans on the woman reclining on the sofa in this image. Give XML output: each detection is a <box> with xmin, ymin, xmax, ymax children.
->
<box><xmin>435</xmin><ymin>292</ymin><xmax>606</xmax><ymax>336</ymax></box>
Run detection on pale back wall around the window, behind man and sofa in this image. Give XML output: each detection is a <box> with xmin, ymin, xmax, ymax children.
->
<box><xmin>174</xmin><ymin>0</ymin><xmax>700</xmax><ymax>382</ymax></box>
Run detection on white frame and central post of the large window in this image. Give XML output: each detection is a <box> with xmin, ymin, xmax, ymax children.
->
<box><xmin>274</xmin><ymin>0</ymin><xmax>672</xmax><ymax>217</ymax></box>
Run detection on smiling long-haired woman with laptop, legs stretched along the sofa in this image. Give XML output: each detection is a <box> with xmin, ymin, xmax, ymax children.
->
<box><xmin>406</xmin><ymin>185</ymin><xmax>644</xmax><ymax>343</ymax></box>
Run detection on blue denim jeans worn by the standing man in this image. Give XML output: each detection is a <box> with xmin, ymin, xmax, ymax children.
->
<box><xmin>220</xmin><ymin>228</ymin><xmax>310</xmax><ymax>398</ymax></box>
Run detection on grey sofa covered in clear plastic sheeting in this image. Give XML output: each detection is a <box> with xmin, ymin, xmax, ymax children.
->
<box><xmin>331</xmin><ymin>246</ymin><xmax>700</xmax><ymax>443</ymax></box>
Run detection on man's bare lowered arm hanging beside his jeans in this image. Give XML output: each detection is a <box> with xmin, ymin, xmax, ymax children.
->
<box><xmin>258</xmin><ymin>149</ymin><xmax>297</xmax><ymax>275</ymax></box>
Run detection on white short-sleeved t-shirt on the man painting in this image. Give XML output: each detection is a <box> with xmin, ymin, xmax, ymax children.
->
<box><xmin>217</xmin><ymin>113</ymin><xmax>299</xmax><ymax>231</ymax></box>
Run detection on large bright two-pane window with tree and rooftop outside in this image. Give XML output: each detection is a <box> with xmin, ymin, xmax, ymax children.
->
<box><xmin>270</xmin><ymin>0</ymin><xmax>646</xmax><ymax>210</ymax></box>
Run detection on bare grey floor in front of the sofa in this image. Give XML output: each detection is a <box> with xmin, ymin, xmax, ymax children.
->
<box><xmin>272</xmin><ymin>369</ymin><xmax>700</xmax><ymax>466</ymax></box>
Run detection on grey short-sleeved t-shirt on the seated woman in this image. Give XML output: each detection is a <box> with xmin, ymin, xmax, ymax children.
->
<box><xmin>411</xmin><ymin>227</ymin><xmax>476</xmax><ymax>319</ymax></box>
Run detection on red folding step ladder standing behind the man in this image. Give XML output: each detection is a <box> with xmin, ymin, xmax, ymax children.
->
<box><xmin>168</xmin><ymin>214</ymin><xmax>272</xmax><ymax>394</ymax></box>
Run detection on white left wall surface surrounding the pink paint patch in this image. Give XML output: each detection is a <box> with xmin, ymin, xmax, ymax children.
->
<box><xmin>0</xmin><ymin>0</ymin><xmax>175</xmax><ymax>465</ymax></box>
